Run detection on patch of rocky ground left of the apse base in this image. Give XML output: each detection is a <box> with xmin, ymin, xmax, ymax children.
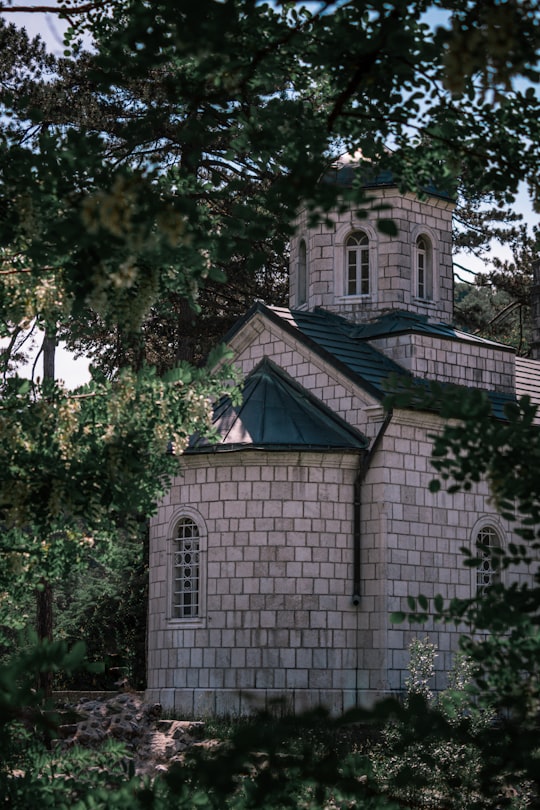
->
<box><xmin>56</xmin><ymin>692</ymin><xmax>209</xmax><ymax>776</ymax></box>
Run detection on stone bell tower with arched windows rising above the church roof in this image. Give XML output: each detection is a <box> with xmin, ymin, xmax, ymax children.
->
<box><xmin>289</xmin><ymin>164</ymin><xmax>455</xmax><ymax>323</ymax></box>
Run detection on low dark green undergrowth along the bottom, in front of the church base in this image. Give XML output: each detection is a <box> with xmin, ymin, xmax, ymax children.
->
<box><xmin>0</xmin><ymin>639</ymin><xmax>534</xmax><ymax>810</ymax></box>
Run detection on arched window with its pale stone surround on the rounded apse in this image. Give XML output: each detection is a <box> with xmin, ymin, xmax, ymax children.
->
<box><xmin>167</xmin><ymin>507</ymin><xmax>207</xmax><ymax>627</ymax></box>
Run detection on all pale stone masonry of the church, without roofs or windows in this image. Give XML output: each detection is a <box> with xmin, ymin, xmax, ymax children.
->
<box><xmin>147</xmin><ymin>181</ymin><xmax>531</xmax><ymax>716</ymax></box>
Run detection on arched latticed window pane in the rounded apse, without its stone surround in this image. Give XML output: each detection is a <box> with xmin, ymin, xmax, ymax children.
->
<box><xmin>171</xmin><ymin>517</ymin><xmax>201</xmax><ymax>619</ymax></box>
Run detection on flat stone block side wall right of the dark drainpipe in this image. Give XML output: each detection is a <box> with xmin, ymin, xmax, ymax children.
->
<box><xmin>361</xmin><ymin>411</ymin><xmax>531</xmax><ymax>691</ymax></box>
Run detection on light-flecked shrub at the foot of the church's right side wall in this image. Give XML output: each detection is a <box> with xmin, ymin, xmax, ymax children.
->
<box><xmin>368</xmin><ymin>638</ymin><xmax>516</xmax><ymax>810</ymax></box>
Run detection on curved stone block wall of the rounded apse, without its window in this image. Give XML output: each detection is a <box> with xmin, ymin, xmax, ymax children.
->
<box><xmin>147</xmin><ymin>451</ymin><xmax>373</xmax><ymax>715</ymax></box>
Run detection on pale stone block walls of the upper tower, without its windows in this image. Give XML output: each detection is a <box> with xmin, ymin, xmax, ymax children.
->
<box><xmin>289</xmin><ymin>188</ymin><xmax>454</xmax><ymax>322</ymax></box>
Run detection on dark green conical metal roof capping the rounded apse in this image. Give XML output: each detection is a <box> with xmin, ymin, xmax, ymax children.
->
<box><xmin>188</xmin><ymin>358</ymin><xmax>368</xmax><ymax>452</ymax></box>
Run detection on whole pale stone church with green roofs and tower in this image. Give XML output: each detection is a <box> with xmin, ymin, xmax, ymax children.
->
<box><xmin>143</xmin><ymin>166</ymin><xmax>540</xmax><ymax>715</ymax></box>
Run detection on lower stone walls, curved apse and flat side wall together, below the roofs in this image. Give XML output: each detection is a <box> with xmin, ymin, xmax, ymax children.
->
<box><xmin>147</xmin><ymin>411</ymin><xmax>527</xmax><ymax>716</ymax></box>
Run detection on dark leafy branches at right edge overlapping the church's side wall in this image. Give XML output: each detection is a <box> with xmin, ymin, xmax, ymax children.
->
<box><xmin>386</xmin><ymin>384</ymin><xmax>540</xmax><ymax>800</ymax></box>
